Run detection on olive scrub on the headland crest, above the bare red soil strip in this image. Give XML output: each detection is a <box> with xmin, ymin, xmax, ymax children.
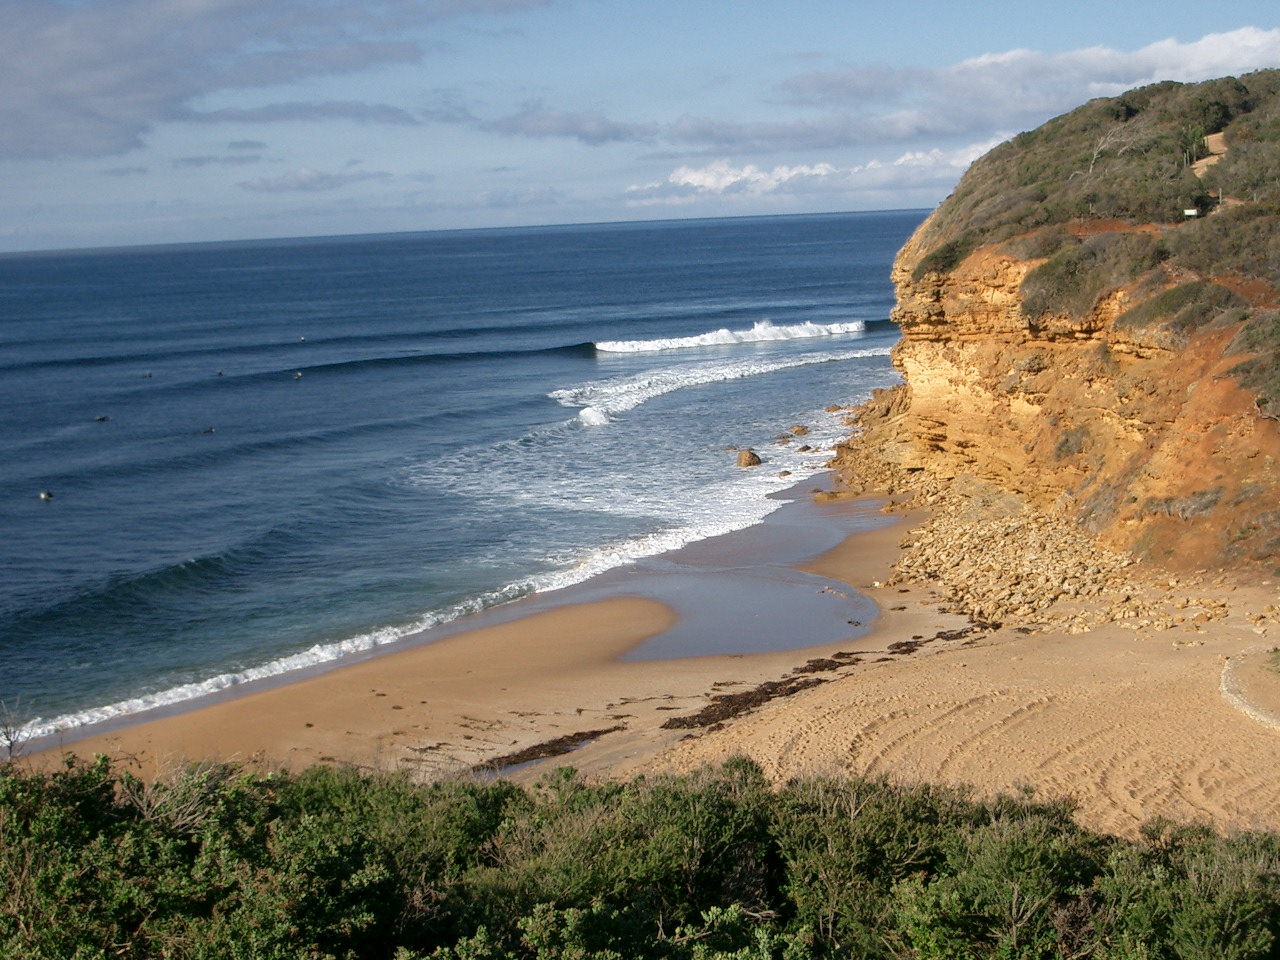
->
<box><xmin>916</xmin><ymin>70</ymin><xmax>1280</xmax><ymax>278</ymax></box>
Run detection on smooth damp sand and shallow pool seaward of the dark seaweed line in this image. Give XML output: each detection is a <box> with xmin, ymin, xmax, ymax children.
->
<box><xmin>26</xmin><ymin>488</ymin><xmax>921</xmax><ymax>776</ymax></box>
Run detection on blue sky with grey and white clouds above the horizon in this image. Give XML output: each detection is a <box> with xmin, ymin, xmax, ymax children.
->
<box><xmin>0</xmin><ymin>0</ymin><xmax>1280</xmax><ymax>252</ymax></box>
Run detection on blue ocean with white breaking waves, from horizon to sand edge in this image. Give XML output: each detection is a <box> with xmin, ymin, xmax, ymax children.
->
<box><xmin>0</xmin><ymin>211</ymin><xmax>924</xmax><ymax>733</ymax></box>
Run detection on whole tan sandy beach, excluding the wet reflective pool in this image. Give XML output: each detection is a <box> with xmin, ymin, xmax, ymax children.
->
<box><xmin>27</xmin><ymin>483</ymin><xmax>1280</xmax><ymax>836</ymax></box>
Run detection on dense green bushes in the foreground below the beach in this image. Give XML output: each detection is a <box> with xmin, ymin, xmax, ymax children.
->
<box><xmin>0</xmin><ymin>758</ymin><xmax>1280</xmax><ymax>960</ymax></box>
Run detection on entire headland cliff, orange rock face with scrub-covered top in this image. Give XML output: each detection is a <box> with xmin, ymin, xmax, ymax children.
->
<box><xmin>837</xmin><ymin>72</ymin><xmax>1280</xmax><ymax>572</ymax></box>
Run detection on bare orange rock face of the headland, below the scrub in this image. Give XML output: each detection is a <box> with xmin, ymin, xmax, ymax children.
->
<box><xmin>841</xmin><ymin>215</ymin><xmax>1280</xmax><ymax>572</ymax></box>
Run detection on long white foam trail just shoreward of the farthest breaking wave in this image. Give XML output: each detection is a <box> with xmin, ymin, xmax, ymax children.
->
<box><xmin>548</xmin><ymin>347</ymin><xmax>890</xmax><ymax>426</ymax></box>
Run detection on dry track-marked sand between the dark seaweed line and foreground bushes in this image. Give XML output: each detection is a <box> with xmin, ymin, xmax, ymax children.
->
<box><xmin>645</xmin><ymin>570</ymin><xmax>1280</xmax><ymax>836</ymax></box>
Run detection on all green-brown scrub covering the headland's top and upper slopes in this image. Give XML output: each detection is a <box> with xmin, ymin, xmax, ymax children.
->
<box><xmin>911</xmin><ymin>70</ymin><xmax>1280</xmax><ymax>416</ymax></box>
